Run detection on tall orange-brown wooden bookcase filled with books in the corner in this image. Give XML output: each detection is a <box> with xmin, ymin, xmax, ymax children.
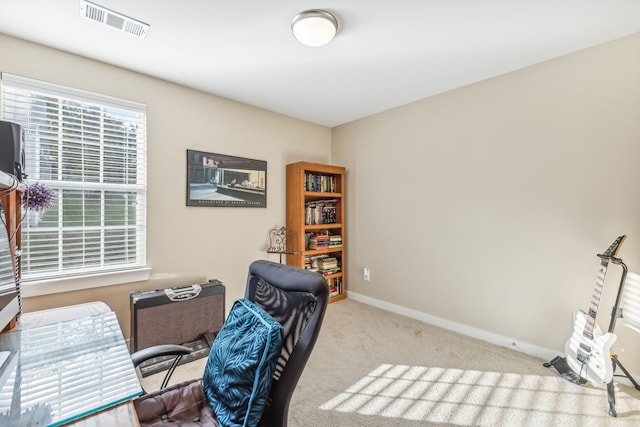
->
<box><xmin>286</xmin><ymin>162</ymin><xmax>347</xmax><ymax>302</ymax></box>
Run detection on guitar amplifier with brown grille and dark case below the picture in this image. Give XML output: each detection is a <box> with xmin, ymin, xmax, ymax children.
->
<box><xmin>131</xmin><ymin>279</ymin><xmax>225</xmax><ymax>351</ymax></box>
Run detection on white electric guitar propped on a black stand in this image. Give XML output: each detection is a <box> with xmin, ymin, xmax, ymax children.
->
<box><xmin>564</xmin><ymin>235</ymin><xmax>627</xmax><ymax>384</ymax></box>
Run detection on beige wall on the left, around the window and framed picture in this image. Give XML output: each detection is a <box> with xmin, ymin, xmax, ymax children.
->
<box><xmin>0</xmin><ymin>35</ymin><xmax>331</xmax><ymax>336</ymax></box>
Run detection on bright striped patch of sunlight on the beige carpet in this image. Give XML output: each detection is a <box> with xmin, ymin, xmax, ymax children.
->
<box><xmin>320</xmin><ymin>364</ymin><xmax>640</xmax><ymax>426</ymax></box>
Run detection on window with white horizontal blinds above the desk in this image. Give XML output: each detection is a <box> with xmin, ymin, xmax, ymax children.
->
<box><xmin>0</xmin><ymin>73</ymin><xmax>146</xmax><ymax>285</ymax></box>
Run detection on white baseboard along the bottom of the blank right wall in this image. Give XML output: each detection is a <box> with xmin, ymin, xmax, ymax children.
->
<box><xmin>347</xmin><ymin>291</ymin><xmax>640</xmax><ymax>387</ymax></box>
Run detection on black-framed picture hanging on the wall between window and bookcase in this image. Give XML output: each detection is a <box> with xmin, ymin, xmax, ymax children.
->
<box><xmin>187</xmin><ymin>150</ymin><xmax>267</xmax><ymax>208</ymax></box>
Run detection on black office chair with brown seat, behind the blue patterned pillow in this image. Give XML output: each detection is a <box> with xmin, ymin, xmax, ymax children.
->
<box><xmin>134</xmin><ymin>261</ymin><xmax>329</xmax><ymax>427</ymax></box>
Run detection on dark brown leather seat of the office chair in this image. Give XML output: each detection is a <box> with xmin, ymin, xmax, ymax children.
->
<box><xmin>133</xmin><ymin>379</ymin><xmax>219</xmax><ymax>427</ymax></box>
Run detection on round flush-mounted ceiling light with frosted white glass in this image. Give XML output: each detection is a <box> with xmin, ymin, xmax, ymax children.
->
<box><xmin>291</xmin><ymin>9</ymin><xmax>338</xmax><ymax>47</ymax></box>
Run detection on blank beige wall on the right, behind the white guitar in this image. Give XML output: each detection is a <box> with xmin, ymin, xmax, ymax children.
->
<box><xmin>332</xmin><ymin>35</ymin><xmax>640</xmax><ymax>372</ymax></box>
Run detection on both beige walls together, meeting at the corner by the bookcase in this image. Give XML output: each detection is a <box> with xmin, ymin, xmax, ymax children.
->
<box><xmin>5</xmin><ymin>30</ymin><xmax>640</xmax><ymax>372</ymax></box>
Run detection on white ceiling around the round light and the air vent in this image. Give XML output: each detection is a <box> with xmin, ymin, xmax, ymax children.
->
<box><xmin>0</xmin><ymin>0</ymin><xmax>640</xmax><ymax>127</ymax></box>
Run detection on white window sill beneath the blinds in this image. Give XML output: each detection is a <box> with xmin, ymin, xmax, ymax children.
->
<box><xmin>20</xmin><ymin>267</ymin><xmax>151</xmax><ymax>298</ymax></box>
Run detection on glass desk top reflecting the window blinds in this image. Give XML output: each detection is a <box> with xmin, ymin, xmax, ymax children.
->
<box><xmin>0</xmin><ymin>312</ymin><xmax>142</xmax><ymax>426</ymax></box>
